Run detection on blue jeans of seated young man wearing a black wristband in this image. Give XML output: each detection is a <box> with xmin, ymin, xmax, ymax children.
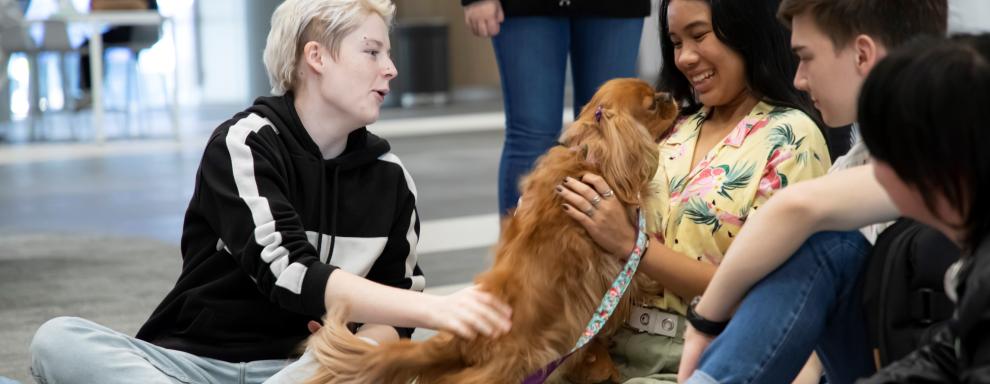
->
<box><xmin>687</xmin><ymin>231</ymin><xmax>875</xmax><ymax>384</ymax></box>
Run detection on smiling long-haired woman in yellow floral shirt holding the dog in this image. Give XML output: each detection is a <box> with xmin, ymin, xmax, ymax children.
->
<box><xmin>558</xmin><ymin>0</ymin><xmax>830</xmax><ymax>383</ymax></box>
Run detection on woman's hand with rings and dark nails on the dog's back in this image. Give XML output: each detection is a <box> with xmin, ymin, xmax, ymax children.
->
<box><xmin>557</xmin><ymin>173</ymin><xmax>636</xmax><ymax>260</ymax></box>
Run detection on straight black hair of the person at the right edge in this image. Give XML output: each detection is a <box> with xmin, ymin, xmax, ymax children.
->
<box><xmin>859</xmin><ymin>35</ymin><xmax>990</xmax><ymax>251</ymax></box>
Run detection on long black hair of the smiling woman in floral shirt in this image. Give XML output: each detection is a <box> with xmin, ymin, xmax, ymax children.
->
<box><xmin>657</xmin><ymin>0</ymin><xmax>825</xmax><ymax>130</ymax></box>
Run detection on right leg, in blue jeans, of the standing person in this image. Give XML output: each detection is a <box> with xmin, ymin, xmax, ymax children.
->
<box><xmin>571</xmin><ymin>17</ymin><xmax>643</xmax><ymax>117</ymax></box>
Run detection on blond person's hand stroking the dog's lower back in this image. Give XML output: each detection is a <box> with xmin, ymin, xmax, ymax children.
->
<box><xmin>430</xmin><ymin>285</ymin><xmax>512</xmax><ymax>339</ymax></box>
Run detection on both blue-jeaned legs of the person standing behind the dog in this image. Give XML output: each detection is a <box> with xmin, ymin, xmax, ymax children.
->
<box><xmin>492</xmin><ymin>17</ymin><xmax>643</xmax><ymax>215</ymax></box>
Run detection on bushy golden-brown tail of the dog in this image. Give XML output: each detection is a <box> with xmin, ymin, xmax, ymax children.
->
<box><xmin>306</xmin><ymin>311</ymin><xmax>462</xmax><ymax>384</ymax></box>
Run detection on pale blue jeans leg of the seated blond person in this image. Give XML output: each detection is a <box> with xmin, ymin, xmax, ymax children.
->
<box><xmin>30</xmin><ymin>317</ymin><xmax>289</xmax><ymax>384</ymax></box>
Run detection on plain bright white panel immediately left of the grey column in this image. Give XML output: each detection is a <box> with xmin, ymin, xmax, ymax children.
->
<box><xmin>196</xmin><ymin>0</ymin><xmax>247</xmax><ymax>104</ymax></box>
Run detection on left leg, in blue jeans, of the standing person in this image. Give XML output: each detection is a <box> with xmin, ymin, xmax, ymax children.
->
<box><xmin>492</xmin><ymin>17</ymin><xmax>570</xmax><ymax>215</ymax></box>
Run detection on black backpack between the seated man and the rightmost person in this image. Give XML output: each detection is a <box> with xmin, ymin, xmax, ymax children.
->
<box><xmin>861</xmin><ymin>218</ymin><xmax>959</xmax><ymax>368</ymax></box>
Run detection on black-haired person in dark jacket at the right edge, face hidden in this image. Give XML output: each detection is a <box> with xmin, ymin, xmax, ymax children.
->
<box><xmin>859</xmin><ymin>34</ymin><xmax>990</xmax><ymax>384</ymax></box>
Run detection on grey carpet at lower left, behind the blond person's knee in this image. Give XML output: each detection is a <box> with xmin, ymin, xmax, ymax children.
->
<box><xmin>0</xmin><ymin>233</ymin><xmax>181</xmax><ymax>384</ymax></box>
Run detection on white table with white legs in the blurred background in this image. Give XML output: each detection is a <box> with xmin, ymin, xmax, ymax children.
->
<box><xmin>32</xmin><ymin>10</ymin><xmax>179</xmax><ymax>143</ymax></box>
